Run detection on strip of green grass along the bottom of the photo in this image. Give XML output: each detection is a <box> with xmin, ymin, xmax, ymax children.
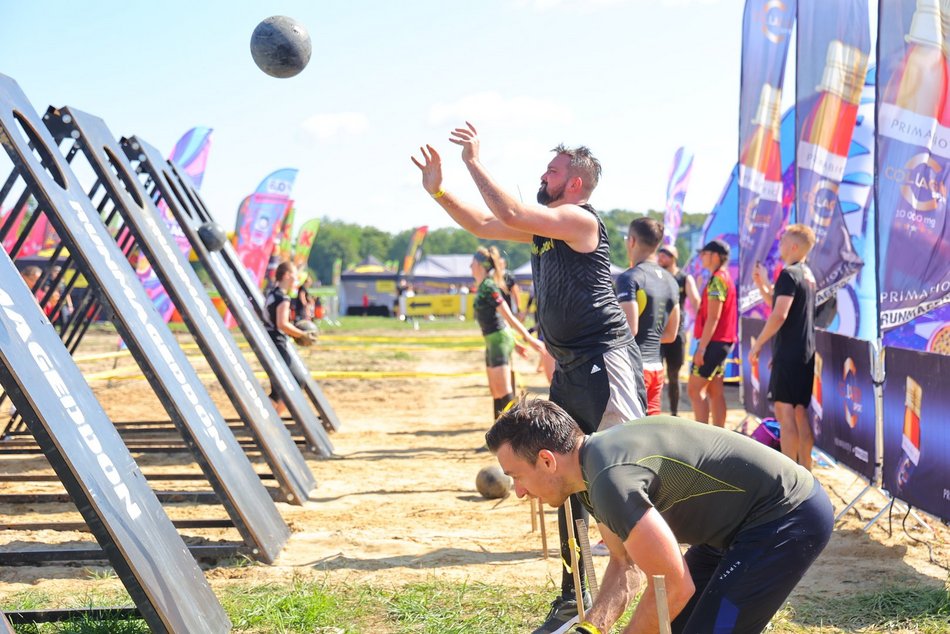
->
<box><xmin>4</xmin><ymin>577</ymin><xmax>950</xmax><ymax>634</ymax></box>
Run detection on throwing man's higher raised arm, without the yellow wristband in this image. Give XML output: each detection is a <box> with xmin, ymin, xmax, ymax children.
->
<box><xmin>449</xmin><ymin>123</ymin><xmax>600</xmax><ymax>253</ymax></box>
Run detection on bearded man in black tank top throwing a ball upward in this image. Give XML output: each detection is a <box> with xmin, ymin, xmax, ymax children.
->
<box><xmin>412</xmin><ymin>124</ymin><xmax>646</xmax><ymax>634</ymax></box>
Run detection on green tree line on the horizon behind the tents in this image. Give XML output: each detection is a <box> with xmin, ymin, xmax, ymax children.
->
<box><xmin>308</xmin><ymin>209</ymin><xmax>707</xmax><ymax>283</ymax></box>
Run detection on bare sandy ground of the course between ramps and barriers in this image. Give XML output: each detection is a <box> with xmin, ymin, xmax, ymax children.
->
<box><xmin>0</xmin><ymin>330</ymin><xmax>950</xmax><ymax>628</ymax></box>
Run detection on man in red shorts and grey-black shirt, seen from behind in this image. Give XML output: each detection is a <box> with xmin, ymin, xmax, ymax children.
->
<box><xmin>617</xmin><ymin>217</ymin><xmax>680</xmax><ymax>416</ymax></box>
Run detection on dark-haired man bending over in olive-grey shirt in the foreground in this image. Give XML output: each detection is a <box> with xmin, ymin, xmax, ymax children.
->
<box><xmin>485</xmin><ymin>400</ymin><xmax>834</xmax><ymax>634</ymax></box>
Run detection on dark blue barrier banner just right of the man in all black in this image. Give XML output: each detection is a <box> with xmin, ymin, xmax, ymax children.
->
<box><xmin>808</xmin><ymin>330</ymin><xmax>876</xmax><ymax>481</ymax></box>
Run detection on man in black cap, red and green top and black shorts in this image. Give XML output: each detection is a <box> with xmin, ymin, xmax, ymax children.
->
<box><xmin>686</xmin><ymin>238</ymin><xmax>739</xmax><ymax>427</ymax></box>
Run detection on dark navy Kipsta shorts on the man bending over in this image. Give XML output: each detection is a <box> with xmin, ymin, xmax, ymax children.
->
<box><xmin>672</xmin><ymin>480</ymin><xmax>834</xmax><ymax>634</ymax></box>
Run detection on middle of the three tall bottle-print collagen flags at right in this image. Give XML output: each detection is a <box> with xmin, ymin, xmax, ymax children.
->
<box><xmin>795</xmin><ymin>0</ymin><xmax>871</xmax><ymax>304</ymax></box>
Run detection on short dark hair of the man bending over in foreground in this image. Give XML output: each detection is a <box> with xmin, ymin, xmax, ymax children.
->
<box><xmin>485</xmin><ymin>397</ymin><xmax>584</xmax><ymax>464</ymax></box>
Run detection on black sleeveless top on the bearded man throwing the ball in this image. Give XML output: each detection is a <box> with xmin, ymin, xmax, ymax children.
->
<box><xmin>531</xmin><ymin>205</ymin><xmax>633</xmax><ymax>370</ymax></box>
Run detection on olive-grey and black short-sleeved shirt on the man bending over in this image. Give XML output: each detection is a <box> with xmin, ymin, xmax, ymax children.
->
<box><xmin>579</xmin><ymin>416</ymin><xmax>815</xmax><ymax>549</ymax></box>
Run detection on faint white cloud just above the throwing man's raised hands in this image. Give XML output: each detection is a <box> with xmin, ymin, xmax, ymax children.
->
<box><xmin>429</xmin><ymin>92</ymin><xmax>574</xmax><ymax>125</ymax></box>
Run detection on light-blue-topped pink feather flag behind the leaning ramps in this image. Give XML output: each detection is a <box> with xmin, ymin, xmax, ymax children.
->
<box><xmin>236</xmin><ymin>168</ymin><xmax>297</xmax><ymax>285</ymax></box>
